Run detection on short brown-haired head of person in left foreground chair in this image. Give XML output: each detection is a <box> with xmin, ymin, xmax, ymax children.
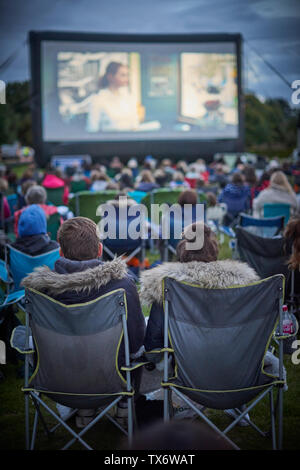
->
<box><xmin>57</xmin><ymin>217</ymin><xmax>102</xmax><ymax>261</ymax></box>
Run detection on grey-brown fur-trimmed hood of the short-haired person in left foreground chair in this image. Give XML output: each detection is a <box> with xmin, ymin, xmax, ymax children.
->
<box><xmin>21</xmin><ymin>258</ymin><xmax>127</xmax><ymax>296</ymax></box>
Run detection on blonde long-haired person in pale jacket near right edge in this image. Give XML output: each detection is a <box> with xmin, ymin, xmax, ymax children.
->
<box><xmin>253</xmin><ymin>170</ymin><xmax>299</xmax><ymax>216</ymax></box>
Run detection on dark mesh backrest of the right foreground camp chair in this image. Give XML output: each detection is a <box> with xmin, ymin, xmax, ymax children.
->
<box><xmin>164</xmin><ymin>275</ymin><xmax>283</xmax><ymax>391</ymax></box>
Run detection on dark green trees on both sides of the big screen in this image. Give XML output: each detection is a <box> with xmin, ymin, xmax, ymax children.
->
<box><xmin>0</xmin><ymin>81</ymin><xmax>297</xmax><ymax>156</ymax></box>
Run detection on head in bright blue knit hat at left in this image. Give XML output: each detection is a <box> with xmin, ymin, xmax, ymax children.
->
<box><xmin>18</xmin><ymin>204</ymin><xmax>47</xmax><ymax>238</ymax></box>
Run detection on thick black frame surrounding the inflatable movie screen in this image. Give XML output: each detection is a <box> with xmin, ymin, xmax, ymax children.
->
<box><xmin>29</xmin><ymin>31</ymin><xmax>245</xmax><ymax>167</ymax></box>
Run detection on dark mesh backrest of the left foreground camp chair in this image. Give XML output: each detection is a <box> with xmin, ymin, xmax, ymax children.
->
<box><xmin>26</xmin><ymin>289</ymin><xmax>126</xmax><ymax>395</ymax></box>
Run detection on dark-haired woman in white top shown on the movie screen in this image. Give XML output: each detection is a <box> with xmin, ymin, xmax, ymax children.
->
<box><xmin>87</xmin><ymin>62</ymin><xmax>139</xmax><ymax>132</ymax></box>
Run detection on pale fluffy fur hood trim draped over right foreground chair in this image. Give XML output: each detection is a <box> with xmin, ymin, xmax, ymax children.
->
<box><xmin>140</xmin><ymin>260</ymin><xmax>259</xmax><ymax>306</ymax></box>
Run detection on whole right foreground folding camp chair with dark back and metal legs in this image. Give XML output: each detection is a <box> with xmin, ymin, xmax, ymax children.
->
<box><xmin>162</xmin><ymin>275</ymin><xmax>285</xmax><ymax>449</ymax></box>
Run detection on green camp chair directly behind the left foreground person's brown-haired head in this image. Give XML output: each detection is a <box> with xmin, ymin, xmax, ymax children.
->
<box><xmin>69</xmin><ymin>190</ymin><xmax>118</xmax><ymax>223</ymax></box>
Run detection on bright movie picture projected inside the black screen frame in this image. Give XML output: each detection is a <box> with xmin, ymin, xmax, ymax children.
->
<box><xmin>41</xmin><ymin>41</ymin><xmax>239</xmax><ymax>141</ymax></box>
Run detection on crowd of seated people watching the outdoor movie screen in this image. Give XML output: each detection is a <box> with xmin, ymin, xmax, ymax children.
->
<box><xmin>0</xmin><ymin>156</ymin><xmax>300</xmax><ymax>448</ymax></box>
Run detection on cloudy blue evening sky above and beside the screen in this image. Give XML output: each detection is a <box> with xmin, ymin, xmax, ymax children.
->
<box><xmin>0</xmin><ymin>0</ymin><xmax>300</xmax><ymax>104</ymax></box>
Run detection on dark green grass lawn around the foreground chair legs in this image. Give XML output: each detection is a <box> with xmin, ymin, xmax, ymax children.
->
<box><xmin>0</xmin><ymin>235</ymin><xmax>300</xmax><ymax>450</ymax></box>
